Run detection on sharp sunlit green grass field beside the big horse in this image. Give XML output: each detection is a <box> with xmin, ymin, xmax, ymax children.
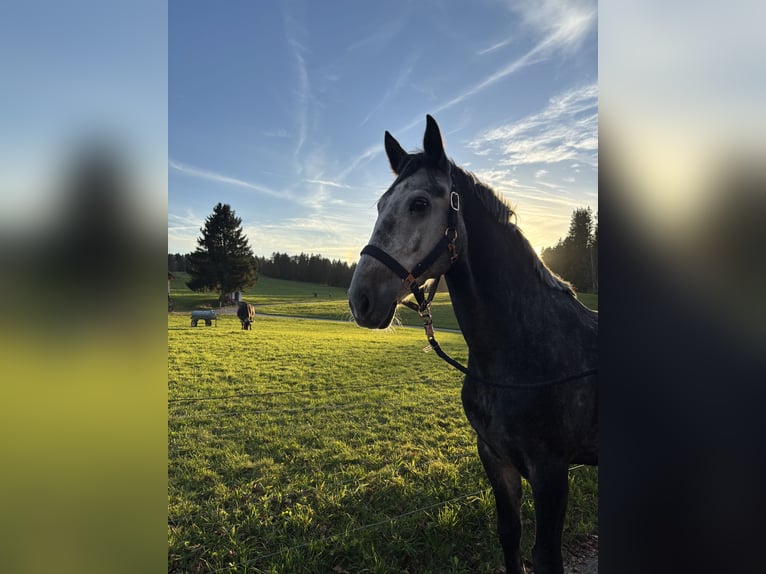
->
<box><xmin>168</xmin><ymin>278</ymin><xmax>598</xmax><ymax>574</ymax></box>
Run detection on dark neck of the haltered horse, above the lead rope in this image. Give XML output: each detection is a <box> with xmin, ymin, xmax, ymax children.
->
<box><xmin>445</xmin><ymin>191</ymin><xmax>594</xmax><ymax>380</ymax></box>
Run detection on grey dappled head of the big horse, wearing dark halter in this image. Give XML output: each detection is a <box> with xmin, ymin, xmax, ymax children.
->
<box><xmin>348</xmin><ymin>116</ymin><xmax>462</xmax><ymax>329</ymax></box>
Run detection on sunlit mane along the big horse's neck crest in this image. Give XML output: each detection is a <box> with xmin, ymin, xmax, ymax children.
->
<box><xmin>450</xmin><ymin>161</ymin><xmax>574</xmax><ymax>296</ymax></box>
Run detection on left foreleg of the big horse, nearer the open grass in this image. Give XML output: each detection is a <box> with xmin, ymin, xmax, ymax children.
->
<box><xmin>478</xmin><ymin>437</ymin><xmax>526</xmax><ymax>574</ymax></box>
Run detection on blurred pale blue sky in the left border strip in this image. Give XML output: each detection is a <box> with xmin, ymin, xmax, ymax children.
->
<box><xmin>0</xmin><ymin>0</ymin><xmax>168</xmax><ymax>234</ymax></box>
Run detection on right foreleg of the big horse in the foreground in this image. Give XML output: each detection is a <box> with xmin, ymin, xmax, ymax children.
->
<box><xmin>529</xmin><ymin>464</ymin><xmax>569</xmax><ymax>574</ymax></box>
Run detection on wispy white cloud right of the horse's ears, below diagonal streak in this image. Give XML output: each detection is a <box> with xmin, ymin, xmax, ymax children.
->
<box><xmin>467</xmin><ymin>83</ymin><xmax>598</xmax><ymax>167</ymax></box>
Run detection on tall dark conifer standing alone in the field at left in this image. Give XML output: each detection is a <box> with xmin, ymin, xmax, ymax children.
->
<box><xmin>186</xmin><ymin>203</ymin><xmax>258</xmax><ymax>299</ymax></box>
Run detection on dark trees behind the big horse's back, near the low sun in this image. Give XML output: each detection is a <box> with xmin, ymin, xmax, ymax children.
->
<box><xmin>541</xmin><ymin>207</ymin><xmax>598</xmax><ymax>293</ymax></box>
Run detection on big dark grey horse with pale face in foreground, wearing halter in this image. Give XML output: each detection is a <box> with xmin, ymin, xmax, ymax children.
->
<box><xmin>349</xmin><ymin>116</ymin><xmax>598</xmax><ymax>574</ymax></box>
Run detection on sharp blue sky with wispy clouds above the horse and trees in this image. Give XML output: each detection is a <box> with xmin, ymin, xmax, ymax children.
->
<box><xmin>168</xmin><ymin>0</ymin><xmax>598</xmax><ymax>263</ymax></box>
